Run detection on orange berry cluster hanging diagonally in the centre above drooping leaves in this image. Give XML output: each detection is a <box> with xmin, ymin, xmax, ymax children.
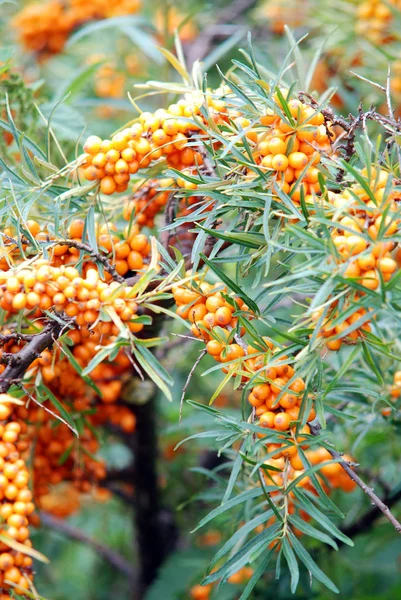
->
<box><xmin>173</xmin><ymin>282</ymin><xmax>315</xmax><ymax>463</ymax></box>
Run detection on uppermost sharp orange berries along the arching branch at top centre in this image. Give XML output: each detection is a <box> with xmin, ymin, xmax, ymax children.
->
<box><xmin>81</xmin><ymin>88</ymin><xmax>334</xmax><ymax>203</ymax></box>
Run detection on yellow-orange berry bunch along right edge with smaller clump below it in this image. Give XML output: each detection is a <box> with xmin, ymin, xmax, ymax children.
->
<box><xmin>312</xmin><ymin>167</ymin><xmax>400</xmax><ymax>350</ymax></box>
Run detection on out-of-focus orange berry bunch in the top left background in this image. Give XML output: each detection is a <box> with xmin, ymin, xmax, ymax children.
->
<box><xmin>13</xmin><ymin>0</ymin><xmax>141</xmax><ymax>56</ymax></box>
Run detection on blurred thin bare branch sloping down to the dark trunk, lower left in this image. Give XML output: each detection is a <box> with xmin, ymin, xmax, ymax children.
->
<box><xmin>39</xmin><ymin>511</ymin><xmax>136</xmax><ymax>582</ymax></box>
